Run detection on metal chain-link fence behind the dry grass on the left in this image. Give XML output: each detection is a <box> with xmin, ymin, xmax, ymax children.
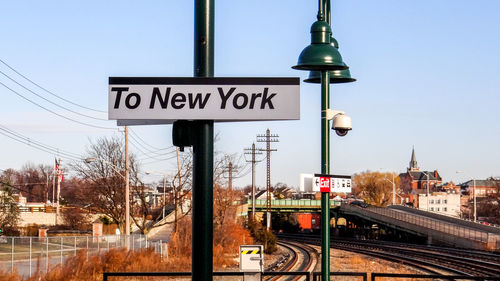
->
<box><xmin>0</xmin><ymin>235</ymin><xmax>164</xmax><ymax>276</ymax></box>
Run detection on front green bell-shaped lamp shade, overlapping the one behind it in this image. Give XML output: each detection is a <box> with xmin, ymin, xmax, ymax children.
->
<box><xmin>292</xmin><ymin>21</ymin><xmax>349</xmax><ymax>71</ymax></box>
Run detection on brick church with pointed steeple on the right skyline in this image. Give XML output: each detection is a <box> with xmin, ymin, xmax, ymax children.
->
<box><xmin>399</xmin><ymin>148</ymin><xmax>443</xmax><ymax>207</ymax></box>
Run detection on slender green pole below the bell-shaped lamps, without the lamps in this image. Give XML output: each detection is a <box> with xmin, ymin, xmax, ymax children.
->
<box><xmin>321</xmin><ymin>68</ymin><xmax>330</xmax><ymax>281</ymax></box>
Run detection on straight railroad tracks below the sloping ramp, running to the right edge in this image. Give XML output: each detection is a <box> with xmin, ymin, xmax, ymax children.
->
<box><xmin>279</xmin><ymin>232</ymin><xmax>500</xmax><ymax>276</ymax></box>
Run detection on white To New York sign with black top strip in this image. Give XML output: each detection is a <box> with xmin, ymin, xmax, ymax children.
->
<box><xmin>108</xmin><ymin>77</ymin><xmax>300</xmax><ymax>125</ymax></box>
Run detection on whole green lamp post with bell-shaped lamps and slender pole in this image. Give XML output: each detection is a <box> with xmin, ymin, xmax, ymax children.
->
<box><xmin>292</xmin><ymin>0</ymin><xmax>350</xmax><ymax>280</ymax></box>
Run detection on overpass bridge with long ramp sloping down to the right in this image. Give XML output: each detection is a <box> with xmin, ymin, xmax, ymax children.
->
<box><xmin>248</xmin><ymin>199</ymin><xmax>500</xmax><ymax>251</ymax></box>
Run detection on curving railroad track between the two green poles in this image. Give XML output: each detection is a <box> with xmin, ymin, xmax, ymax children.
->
<box><xmin>265</xmin><ymin>237</ymin><xmax>317</xmax><ymax>281</ymax></box>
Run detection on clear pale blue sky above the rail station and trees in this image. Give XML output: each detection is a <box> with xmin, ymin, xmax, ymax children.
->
<box><xmin>0</xmin><ymin>0</ymin><xmax>500</xmax><ymax>186</ymax></box>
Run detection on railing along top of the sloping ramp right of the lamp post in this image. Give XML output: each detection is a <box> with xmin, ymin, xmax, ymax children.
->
<box><xmin>342</xmin><ymin>204</ymin><xmax>498</xmax><ymax>243</ymax></box>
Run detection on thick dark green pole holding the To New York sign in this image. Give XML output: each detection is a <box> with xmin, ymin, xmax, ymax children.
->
<box><xmin>191</xmin><ymin>0</ymin><xmax>214</xmax><ymax>281</ymax></box>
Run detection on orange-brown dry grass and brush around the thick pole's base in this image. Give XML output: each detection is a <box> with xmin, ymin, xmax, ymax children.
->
<box><xmin>0</xmin><ymin>215</ymin><xmax>253</xmax><ymax>281</ymax></box>
